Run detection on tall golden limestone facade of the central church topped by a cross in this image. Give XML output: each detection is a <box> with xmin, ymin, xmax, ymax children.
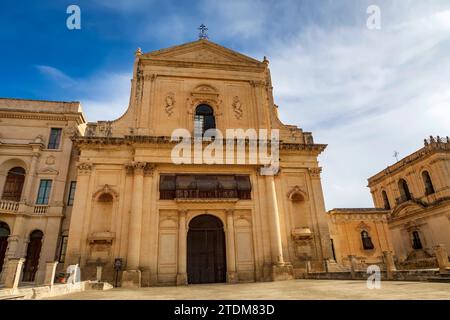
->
<box><xmin>67</xmin><ymin>39</ymin><xmax>331</xmax><ymax>286</ymax></box>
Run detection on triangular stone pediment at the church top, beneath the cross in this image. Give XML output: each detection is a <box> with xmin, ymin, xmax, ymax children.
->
<box><xmin>143</xmin><ymin>39</ymin><xmax>263</xmax><ymax>66</ymax></box>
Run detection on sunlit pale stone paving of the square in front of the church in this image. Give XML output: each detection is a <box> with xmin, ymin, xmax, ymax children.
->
<box><xmin>46</xmin><ymin>280</ymin><xmax>450</xmax><ymax>300</ymax></box>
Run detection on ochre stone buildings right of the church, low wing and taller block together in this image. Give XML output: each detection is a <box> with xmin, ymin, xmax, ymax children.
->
<box><xmin>328</xmin><ymin>137</ymin><xmax>450</xmax><ymax>269</ymax></box>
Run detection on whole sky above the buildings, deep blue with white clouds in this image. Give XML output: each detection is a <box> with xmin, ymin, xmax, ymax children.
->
<box><xmin>0</xmin><ymin>0</ymin><xmax>450</xmax><ymax>209</ymax></box>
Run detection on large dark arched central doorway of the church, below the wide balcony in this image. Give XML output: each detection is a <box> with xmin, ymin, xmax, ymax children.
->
<box><xmin>187</xmin><ymin>214</ymin><xmax>227</xmax><ymax>283</ymax></box>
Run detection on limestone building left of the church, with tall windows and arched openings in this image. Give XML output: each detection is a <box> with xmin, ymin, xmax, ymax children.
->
<box><xmin>0</xmin><ymin>98</ymin><xmax>85</xmax><ymax>283</ymax></box>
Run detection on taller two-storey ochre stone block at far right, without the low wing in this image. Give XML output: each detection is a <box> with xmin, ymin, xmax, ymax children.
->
<box><xmin>369</xmin><ymin>137</ymin><xmax>450</xmax><ymax>268</ymax></box>
